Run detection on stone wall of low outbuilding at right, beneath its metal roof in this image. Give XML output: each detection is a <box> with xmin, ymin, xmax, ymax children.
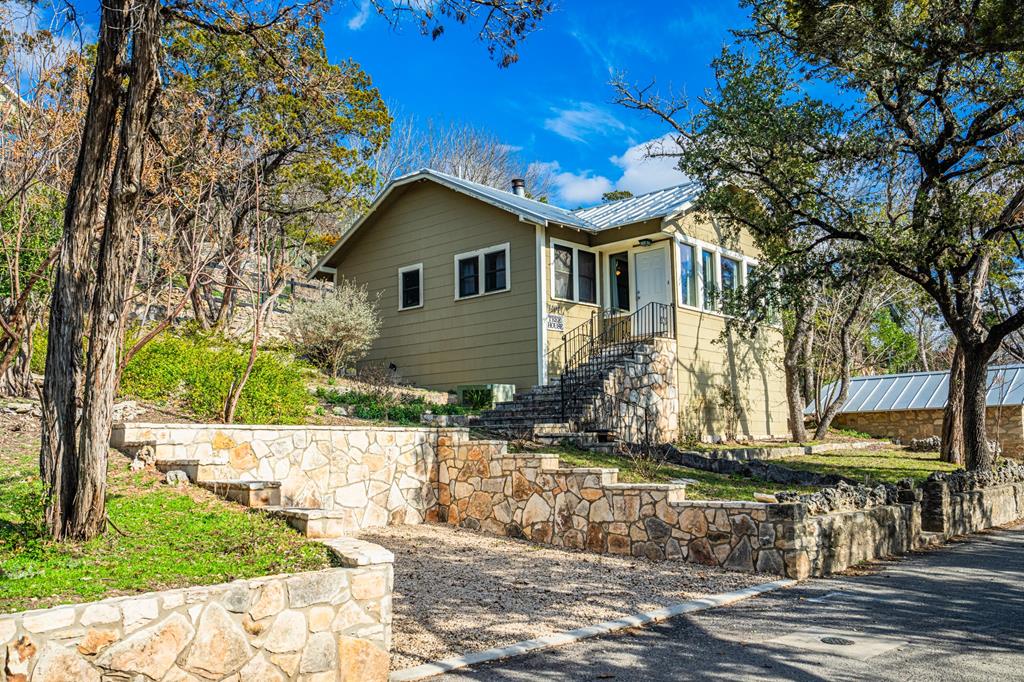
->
<box><xmin>835</xmin><ymin>406</ymin><xmax>1024</xmax><ymax>457</ymax></box>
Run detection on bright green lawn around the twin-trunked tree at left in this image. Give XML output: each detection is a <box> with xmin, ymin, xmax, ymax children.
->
<box><xmin>0</xmin><ymin>413</ymin><xmax>331</xmax><ymax>613</ymax></box>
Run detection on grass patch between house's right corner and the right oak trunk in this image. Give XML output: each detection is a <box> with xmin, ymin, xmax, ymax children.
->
<box><xmin>779</xmin><ymin>447</ymin><xmax>956</xmax><ymax>484</ymax></box>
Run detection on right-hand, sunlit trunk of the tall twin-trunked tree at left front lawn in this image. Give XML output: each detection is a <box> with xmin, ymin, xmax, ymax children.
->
<box><xmin>73</xmin><ymin>0</ymin><xmax>161</xmax><ymax>540</ymax></box>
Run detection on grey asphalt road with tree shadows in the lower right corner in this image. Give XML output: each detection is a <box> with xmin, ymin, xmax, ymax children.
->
<box><xmin>439</xmin><ymin>526</ymin><xmax>1024</xmax><ymax>682</ymax></box>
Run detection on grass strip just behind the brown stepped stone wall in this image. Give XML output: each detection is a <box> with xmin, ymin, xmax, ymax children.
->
<box><xmin>545</xmin><ymin>446</ymin><xmax>817</xmax><ymax>502</ymax></box>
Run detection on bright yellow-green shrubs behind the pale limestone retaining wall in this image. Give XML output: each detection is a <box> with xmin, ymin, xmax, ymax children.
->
<box><xmin>121</xmin><ymin>333</ymin><xmax>313</xmax><ymax>424</ymax></box>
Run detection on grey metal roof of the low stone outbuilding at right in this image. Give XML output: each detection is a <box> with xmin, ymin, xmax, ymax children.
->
<box><xmin>804</xmin><ymin>365</ymin><xmax>1024</xmax><ymax>415</ymax></box>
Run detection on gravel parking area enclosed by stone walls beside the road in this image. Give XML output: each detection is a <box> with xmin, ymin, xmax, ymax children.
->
<box><xmin>359</xmin><ymin>525</ymin><xmax>777</xmax><ymax>670</ymax></box>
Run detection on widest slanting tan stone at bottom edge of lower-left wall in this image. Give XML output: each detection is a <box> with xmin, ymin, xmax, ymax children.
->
<box><xmin>96</xmin><ymin>613</ymin><xmax>196</xmax><ymax>680</ymax></box>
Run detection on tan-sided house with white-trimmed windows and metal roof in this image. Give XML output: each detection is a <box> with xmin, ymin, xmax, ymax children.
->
<box><xmin>312</xmin><ymin>169</ymin><xmax>786</xmax><ymax>437</ymax></box>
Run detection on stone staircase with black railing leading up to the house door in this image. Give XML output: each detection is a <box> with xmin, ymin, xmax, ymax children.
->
<box><xmin>470</xmin><ymin>342</ymin><xmax>650</xmax><ymax>451</ymax></box>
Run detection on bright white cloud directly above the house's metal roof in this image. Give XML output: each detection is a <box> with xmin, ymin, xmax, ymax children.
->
<box><xmin>530</xmin><ymin>134</ymin><xmax>687</xmax><ymax>208</ymax></box>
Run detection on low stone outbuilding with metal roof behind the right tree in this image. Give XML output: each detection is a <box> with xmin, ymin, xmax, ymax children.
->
<box><xmin>805</xmin><ymin>365</ymin><xmax>1024</xmax><ymax>457</ymax></box>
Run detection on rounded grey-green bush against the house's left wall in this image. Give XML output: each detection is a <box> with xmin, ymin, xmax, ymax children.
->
<box><xmin>289</xmin><ymin>280</ymin><xmax>381</xmax><ymax>377</ymax></box>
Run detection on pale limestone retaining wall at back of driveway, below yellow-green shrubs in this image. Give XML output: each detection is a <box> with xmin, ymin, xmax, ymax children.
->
<box><xmin>112</xmin><ymin>424</ymin><xmax>444</xmax><ymax>531</ymax></box>
